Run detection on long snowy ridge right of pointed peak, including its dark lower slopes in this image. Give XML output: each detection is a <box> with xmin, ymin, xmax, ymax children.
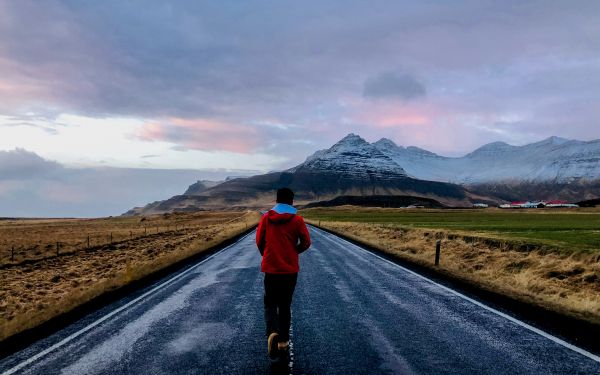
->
<box><xmin>373</xmin><ymin>137</ymin><xmax>600</xmax><ymax>203</ymax></box>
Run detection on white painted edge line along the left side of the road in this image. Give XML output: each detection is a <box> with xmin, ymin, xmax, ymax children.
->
<box><xmin>2</xmin><ymin>232</ymin><xmax>254</xmax><ymax>375</ymax></box>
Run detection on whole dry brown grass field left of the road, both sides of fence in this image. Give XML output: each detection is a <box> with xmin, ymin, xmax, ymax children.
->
<box><xmin>0</xmin><ymin>212</ymin><xmax>260</xmax><ymax>341</ymax></box>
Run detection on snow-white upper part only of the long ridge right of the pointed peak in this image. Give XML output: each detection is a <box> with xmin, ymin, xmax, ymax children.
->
<box><xmin>373</xmin><ymin>137</ymin><xmax>600</xmax><ymax>185</ymax></box>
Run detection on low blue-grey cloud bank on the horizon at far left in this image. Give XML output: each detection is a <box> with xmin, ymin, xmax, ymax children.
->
<box><xmin>0</xmin><ymin>149</ymin><xmax>256</xmax><ymax>217</ymax></box>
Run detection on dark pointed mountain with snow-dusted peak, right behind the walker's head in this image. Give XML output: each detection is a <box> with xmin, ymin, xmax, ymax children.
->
<box><xmin>126</xmin><ymin>134</ymin><xmax>471</xmax><ymax>215</ymax></box>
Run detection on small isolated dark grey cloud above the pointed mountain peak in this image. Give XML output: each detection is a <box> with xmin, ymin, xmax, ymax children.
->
<box><xmin>363</xmin><ymin>72</ymin><xmax>426</xmax><ymax>100</ymax></box>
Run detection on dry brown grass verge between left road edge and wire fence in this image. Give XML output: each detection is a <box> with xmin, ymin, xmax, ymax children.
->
<box><xmin>0</xmin><ymin>212</ymin><xmax>260</xmax><ymax>341</ymax></box>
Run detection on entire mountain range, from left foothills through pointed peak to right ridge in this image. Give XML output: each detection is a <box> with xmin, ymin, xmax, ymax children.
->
<box><xmin>126</xmin><ymin>134</ymin><xmax>600</xmax><ymax>215</ymax></box>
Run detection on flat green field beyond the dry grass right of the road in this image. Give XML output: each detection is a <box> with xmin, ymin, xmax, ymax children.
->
<box><xmin>301</xmin><ymin>208</ymin><xmax>600</xmax><ymax>252</ymax></box>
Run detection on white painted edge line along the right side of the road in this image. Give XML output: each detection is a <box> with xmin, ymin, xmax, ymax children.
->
<box><xmin>311</xmin><ymin>225</ymin><xmax>600</xmax><ymax>363</ymax></box>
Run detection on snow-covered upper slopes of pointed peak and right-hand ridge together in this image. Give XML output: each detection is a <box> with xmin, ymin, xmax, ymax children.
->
<box><xmin>288</xmin><ymin>134</ymin><xmax>600</xmax><ymax>184</ymax></box>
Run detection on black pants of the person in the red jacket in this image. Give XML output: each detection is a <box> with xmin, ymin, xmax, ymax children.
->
<box><xmin>264</xmin><ymin>273</ymin><xmax>298</xmax><ymax>341</ymax></box>
